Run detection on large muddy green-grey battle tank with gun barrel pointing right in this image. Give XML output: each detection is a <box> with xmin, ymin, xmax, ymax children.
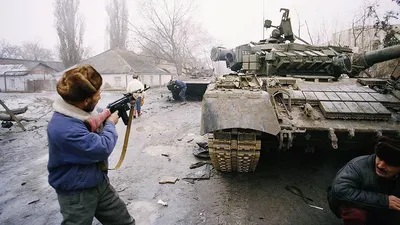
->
<box><xmin>201</xmin><ymin>9</ymin><xmax>400</xmax><ymax>172</ymax></box>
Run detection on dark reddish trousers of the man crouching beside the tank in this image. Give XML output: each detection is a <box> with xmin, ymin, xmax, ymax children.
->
<box><xmin>339</xmin><ymin>206</ymin><xmax>400</xmax><ymax>225</ymax></box>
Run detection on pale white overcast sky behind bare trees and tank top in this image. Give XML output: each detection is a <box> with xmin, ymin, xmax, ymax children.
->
<box><xmin>0</xmin><ymin>0</ymin><xmax>399</xmax><ymax>58</ymax></box>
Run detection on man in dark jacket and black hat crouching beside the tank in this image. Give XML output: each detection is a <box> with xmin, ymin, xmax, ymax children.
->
<box><xmin>328</xmin><ymin>137</ymin><xmax>400</xmax><ymax>225</ymax></box>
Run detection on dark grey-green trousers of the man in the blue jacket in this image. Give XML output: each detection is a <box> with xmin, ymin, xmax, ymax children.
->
<box><xmin>58</xmin><ymin>179</ymin><xmax>135</xmax><ymax>225</ymax></box>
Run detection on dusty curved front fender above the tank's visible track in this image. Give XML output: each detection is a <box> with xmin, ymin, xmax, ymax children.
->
<box><xmin>200</xmin><ymin>89</ymin><xmax>281</xmax><ymax>135</ymax></box>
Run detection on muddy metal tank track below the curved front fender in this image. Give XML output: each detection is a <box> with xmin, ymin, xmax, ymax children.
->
<box><xmin>208</xmin><ymin>129</ymin><xmax>261</xmax><ymax>172</ymax></box>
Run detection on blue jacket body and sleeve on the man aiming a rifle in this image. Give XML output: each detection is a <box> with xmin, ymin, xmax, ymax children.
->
<box><xmin>47</xmin><ymin>112</ymin><xmax>118</xmax><ymax>194</ymax></box>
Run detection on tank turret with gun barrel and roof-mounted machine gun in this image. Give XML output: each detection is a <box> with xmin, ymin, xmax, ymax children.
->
<box><xmin>211</xmin><ymin>9</ymin><xmax>400</xmax><ymax>77</ymax></box>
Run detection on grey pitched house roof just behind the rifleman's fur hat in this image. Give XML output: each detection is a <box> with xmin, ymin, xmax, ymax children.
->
<box><xmin>61</xmin><ymin>49</ymin><xmax>168</xmax><ymax>75</ymax></box>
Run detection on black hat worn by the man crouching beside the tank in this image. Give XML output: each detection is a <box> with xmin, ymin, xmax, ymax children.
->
<box><xmin>375</xmin><ymin>137</ymin><xmax>400</xmax><ymax>166</ymax></box>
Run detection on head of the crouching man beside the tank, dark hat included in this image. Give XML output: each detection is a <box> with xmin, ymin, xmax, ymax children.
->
<box><xmin>375</xmin><ymin>137</ymin><xmax>400</xmax><ymax>178</ymax></box>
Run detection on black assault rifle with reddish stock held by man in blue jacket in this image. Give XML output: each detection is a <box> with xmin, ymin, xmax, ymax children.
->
<box><xmin>84</xmin><ymin>87</ymin><xmax>150</xmax><ymax>132</ymax></box>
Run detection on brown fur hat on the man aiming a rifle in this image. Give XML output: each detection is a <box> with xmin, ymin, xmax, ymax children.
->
<box><xmin>57</xmin><ymin>65</ymin><xmax>103</xmax><ymax>102</ymax></box>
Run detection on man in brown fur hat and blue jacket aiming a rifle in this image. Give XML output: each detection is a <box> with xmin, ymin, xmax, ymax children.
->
<box><xmin>47</xmin><ymin>65</ymin><xmax>135</xmax><ymax>225</ymax></box>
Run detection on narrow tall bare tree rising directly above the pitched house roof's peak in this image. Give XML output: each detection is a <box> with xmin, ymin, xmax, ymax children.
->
<box><xmin>106</xmin><ymin>0</ymin><xmax>128</xmax><ymax>49</ymax></box>
